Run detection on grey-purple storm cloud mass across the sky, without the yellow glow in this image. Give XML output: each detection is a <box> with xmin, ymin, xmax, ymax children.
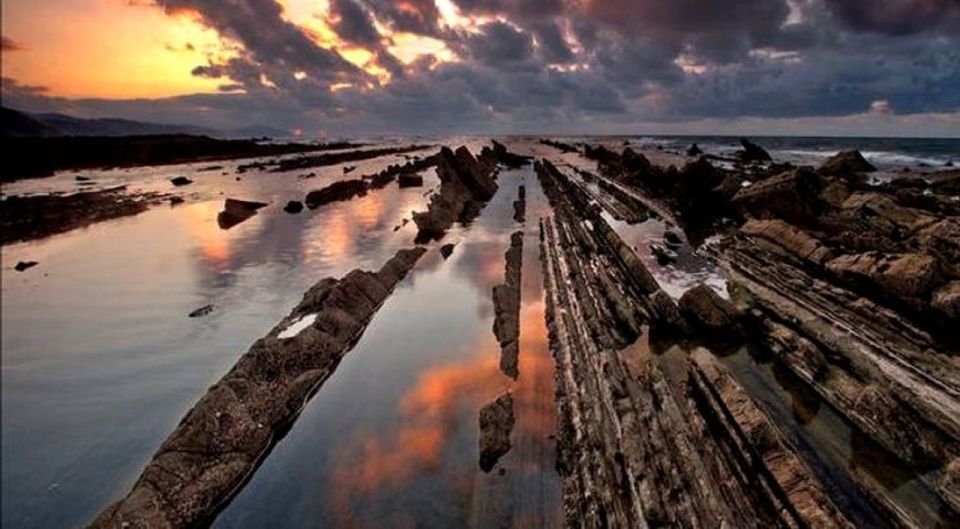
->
<box><xmin>4</xmin><ymin>0</ymin><xmax>960</xmax><ymax>132</ymax></box>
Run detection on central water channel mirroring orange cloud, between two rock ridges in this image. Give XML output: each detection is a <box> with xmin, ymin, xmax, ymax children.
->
<box><xmin>215</xmin><ymin>159</ymin><xmax>561</xmax><ymax>527</ymax></box>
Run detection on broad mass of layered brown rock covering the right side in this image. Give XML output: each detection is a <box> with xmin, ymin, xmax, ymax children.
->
<box><xmin>538</xmin><ymin>140</ymin><xmax>960</xmax><ymax>527</ymax></box>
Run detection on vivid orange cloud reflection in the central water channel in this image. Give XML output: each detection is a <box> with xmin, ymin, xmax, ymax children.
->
<box><xmin>331</xmin><ymin>245</ymin><xmax>556</xmax><ymax>527</ymax></box>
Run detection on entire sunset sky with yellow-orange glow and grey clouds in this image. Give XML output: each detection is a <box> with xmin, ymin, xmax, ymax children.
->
<box><xmin>2</xmin><ymin>0</ymin><xmax>960</xmax><ymax>137</ymax></box>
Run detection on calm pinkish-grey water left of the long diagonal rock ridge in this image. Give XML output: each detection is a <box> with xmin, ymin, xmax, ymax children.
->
<box><xmin>2</xmin><ymin>151</ymin><xmax>437</xmax><ymax>527</ymax></box>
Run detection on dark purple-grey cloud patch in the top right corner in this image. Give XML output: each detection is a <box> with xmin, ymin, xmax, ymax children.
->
<box><xmin>825</xmin><ymin>0</ymin><xmax>960</xmax><ymax>35</ymax></box>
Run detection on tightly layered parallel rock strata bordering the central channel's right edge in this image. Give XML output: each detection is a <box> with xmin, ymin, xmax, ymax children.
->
<box><xmin>537</xmin><ymin>154</ymin><xmax>850</xmax><ymax>527</ymax></box>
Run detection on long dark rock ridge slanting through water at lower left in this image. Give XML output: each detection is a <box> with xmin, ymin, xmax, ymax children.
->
<box><xmin>90</xmin><ymin>248</ymin><xmax>426</xmax><ymax>528</ymax></box>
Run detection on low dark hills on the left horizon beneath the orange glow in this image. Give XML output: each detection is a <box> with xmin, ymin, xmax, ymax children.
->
<box><xmin>0</xmin><ymin>107</ymin><xmax>290</xmax><ymax>139</ymax></box>
